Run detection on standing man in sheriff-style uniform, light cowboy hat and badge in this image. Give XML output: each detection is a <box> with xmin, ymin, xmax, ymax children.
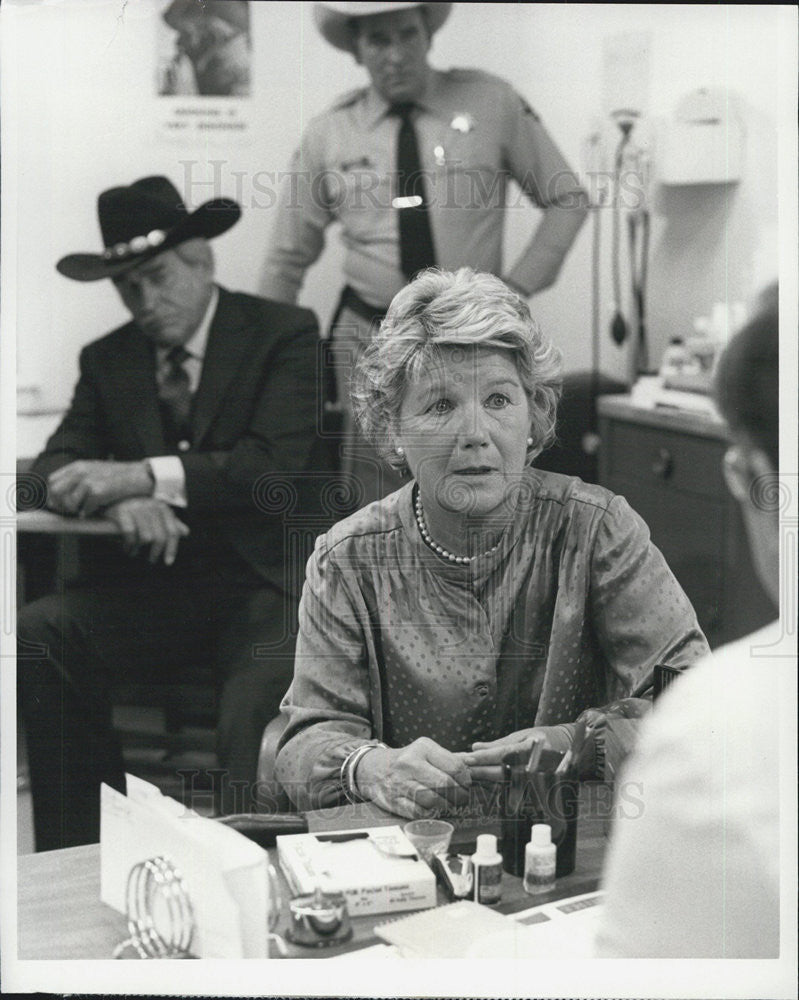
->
<box><xmin>263</xmin><ymin>2</ymin><xmax>587</xmax><ymax>503</ymax></box>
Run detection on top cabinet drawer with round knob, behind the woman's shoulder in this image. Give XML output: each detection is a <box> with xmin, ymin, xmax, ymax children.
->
<box><xmin>602</xmin><ymin>420</ymin><xmax>727</xmax><ymax>500</ymax></box>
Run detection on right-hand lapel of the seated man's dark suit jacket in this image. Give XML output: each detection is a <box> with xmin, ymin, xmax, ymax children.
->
<box><xmin>191</xmin><ymin>288</ymin><xmax>249</xmax><ymax>448</ymax></box>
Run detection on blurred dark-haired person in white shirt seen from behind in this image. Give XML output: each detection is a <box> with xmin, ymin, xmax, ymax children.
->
<box><xmin>597</xmin><ymin>294</ymin><xmax>784</xmax><ymax>958</ymax></box>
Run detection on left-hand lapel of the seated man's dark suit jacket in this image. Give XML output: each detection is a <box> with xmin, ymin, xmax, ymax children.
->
<box><xmin>114</xmin><ymin>323</ymin><xmax>166</xmax><ymax>455</ymax></box>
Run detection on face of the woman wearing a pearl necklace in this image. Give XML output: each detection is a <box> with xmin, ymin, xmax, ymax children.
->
<box><xmin>394</xmin><ymin>347</ymin><xmax>530</xmax><ymax>517</ymax></box>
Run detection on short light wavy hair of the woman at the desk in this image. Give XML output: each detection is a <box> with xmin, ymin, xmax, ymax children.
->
<box><xmin>351</xmin><ymin>267</ymin><xmax>561</xmax><ymax>470</ymax></box>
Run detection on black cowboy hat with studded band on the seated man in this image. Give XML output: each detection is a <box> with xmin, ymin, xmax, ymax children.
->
<box><xmin>56</xmin><ymin>177</ymin><xmax>241</xmax><ymax>281</ymax></box>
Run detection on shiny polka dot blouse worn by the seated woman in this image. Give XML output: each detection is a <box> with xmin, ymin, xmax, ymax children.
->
<box><xmin>278</xmin><ymin>469</ymin><xmax>707</xmax><ymax>804</ymax></box>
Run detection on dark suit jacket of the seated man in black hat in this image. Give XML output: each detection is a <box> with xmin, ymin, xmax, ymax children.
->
<box><xmin>32</xmin><ymin>288</ymin><xmax>331</xmax><ymax>591</ymax></box>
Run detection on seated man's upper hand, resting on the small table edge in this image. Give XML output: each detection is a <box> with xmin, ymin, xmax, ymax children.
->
<box><xmin>47</xmin><ymin>460</ymin><xmax>153</xmax><ymax>517</ymax></box>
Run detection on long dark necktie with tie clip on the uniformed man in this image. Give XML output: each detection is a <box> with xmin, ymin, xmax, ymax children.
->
<box><xmin>390</xmin><ymin>104</ymin><xmax>436</xmax><ymax>281</ymax></box>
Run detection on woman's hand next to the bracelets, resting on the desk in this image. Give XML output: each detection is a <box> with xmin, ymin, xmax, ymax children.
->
<box><xmin>355</xmin><ymin>736</ymin><xmax>472</xmax><ymax>819</ymax></box>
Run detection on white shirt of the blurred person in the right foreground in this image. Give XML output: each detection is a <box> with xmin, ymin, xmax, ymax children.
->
<box><xmin>596</xmin><ymin>651</ymin><xmax>779</xmax><ymax>958</ymax></box>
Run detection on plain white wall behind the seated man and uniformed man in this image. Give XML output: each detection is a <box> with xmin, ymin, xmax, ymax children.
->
<box><xmin>2</xmin><ymin>0</ymin><xmax>795</xmax><ymax>446</ymax></box>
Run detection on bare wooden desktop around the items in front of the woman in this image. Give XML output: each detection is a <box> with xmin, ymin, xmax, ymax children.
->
<box><xmin>17</xmin><ymin>785</ymin><xmax>610</xmax><ymax>960</ymax></box>
